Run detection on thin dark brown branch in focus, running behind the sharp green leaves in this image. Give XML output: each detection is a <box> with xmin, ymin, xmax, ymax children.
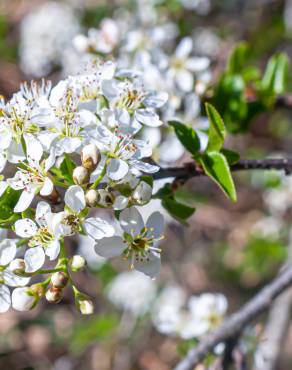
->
<box><xmin>153</xmin><ymin>158</ymin><xmax>292</xmax><ymax>180</ymax></box>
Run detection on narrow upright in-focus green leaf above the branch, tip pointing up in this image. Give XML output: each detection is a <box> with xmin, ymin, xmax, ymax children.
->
<box><xmin>205</xmin><ymin>103</ymin><xmax>226</xmax><ymax>152</ymax></box>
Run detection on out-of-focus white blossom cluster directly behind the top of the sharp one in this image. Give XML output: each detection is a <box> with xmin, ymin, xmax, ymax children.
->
<box><xmin>70</xmin><ymin>13</ymin><xmax>211</xmax><ymax>162</ymax></box>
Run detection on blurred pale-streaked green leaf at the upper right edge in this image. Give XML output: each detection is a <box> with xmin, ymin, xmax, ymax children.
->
<box><xmin>262</xmin><ymin>53</ymin><xmax>289</xmax><ymax>96</ymax></box>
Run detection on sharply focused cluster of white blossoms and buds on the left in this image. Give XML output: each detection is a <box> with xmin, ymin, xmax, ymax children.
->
<box><xmin>0</xmin><ymin>62</ymin><xmax>167</xmax><ymax>314</ymax></box>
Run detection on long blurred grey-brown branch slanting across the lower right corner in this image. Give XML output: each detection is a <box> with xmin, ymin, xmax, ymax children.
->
<box><xmin>175</xmin><ymin>265</ymin><xmax>292</xmax><ymax>370</ymax></box>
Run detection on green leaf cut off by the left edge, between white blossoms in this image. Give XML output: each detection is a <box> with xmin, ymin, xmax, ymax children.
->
<box><xmin>0</xmin><ymin>186</ymin><xmax>21</xmax><ymax>224</ymax></box>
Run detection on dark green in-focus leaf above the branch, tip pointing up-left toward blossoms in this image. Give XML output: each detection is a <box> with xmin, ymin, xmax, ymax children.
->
<box><xmin>168</xmin><ymin>121</ymin><xmax>200</xmax><ymax>155</ymax></box>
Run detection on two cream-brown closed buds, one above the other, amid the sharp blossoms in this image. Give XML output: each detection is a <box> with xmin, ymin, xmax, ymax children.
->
<box><xmin>73</xmin><ymin>144</ymin><xmax>101</xmax><ymax>186</ymax></box>
